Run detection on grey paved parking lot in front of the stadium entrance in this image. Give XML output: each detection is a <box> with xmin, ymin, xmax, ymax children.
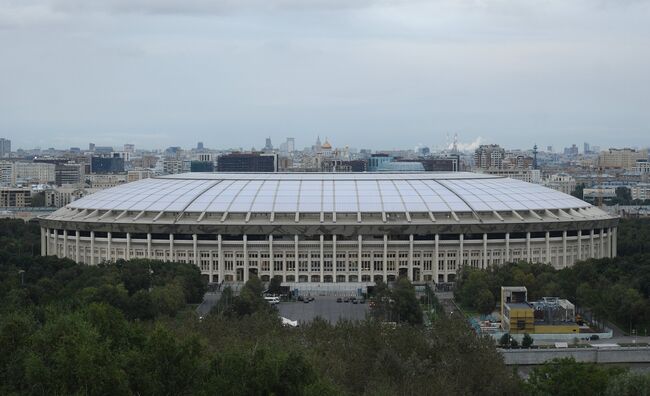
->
<box><xmin>277</xmin><ymin>296</ymin><xmax>368</xmax><ymax>323</ymax></box>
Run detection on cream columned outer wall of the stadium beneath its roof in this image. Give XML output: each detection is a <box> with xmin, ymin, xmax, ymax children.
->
<box><xmin>41</xmin><ymin>227</ymin><xmax>616</xmax><ymax>283</ymax></box>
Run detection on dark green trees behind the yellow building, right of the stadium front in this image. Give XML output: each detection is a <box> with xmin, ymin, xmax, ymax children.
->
<box><xmin>454</xmin><ymin>254</ymin><xmax>650</xmax><ymax>332</ymax></box>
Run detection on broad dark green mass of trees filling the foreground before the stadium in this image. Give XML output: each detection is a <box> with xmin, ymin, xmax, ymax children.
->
<box><xmin>0</xmin><ymin>221</ymin><xmax>646</xmax><ymax>395</ymax></box>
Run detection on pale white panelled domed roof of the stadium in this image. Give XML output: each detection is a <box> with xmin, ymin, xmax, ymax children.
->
<box><xmin>59</xmin><ymin>172</ymin><xmax>592</xmax><ymax>220</ymax></box>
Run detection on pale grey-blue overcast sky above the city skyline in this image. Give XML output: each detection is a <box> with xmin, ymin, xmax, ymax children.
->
<box><xmin>0</xmin><ymin>0</ymin><xmax>650</xmax><ymax>149</ymax></box>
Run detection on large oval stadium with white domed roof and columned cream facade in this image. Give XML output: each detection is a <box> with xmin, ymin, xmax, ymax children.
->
<box><xmin>40</xmin><ymin>172</ymin><xmax>618</xmax><ymax>284</ymax></box>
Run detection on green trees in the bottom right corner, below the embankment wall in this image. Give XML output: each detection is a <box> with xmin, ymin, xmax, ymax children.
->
<box><xmin>524</xmin><ymin>358</ymin><xmax>650</xmax><ymax>396</ymax></box>
